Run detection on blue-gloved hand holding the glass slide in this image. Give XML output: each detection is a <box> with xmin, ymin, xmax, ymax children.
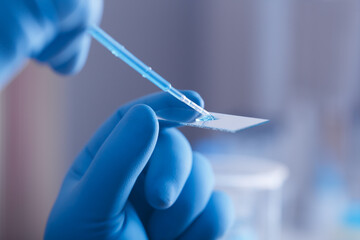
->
<box><xmin>45</xmin><ymin>91</ymin><xmax>233</xmax><ymax>240</ymax></box>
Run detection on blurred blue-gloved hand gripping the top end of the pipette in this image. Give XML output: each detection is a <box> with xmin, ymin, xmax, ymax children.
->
<box><xmin>0</xmin><ymin>0</ymin><xmax>103</xmax><ymax>89</ymax></box>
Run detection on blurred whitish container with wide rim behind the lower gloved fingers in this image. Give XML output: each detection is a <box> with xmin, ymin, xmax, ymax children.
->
<box><xmin>208</xmin><ymin>154</ymin><xmax>288</xmax><ymax>240</ymax></box>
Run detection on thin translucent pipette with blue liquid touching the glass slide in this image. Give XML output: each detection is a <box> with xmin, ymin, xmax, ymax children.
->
<box><xmin>89</xmin><ymin>26</ymin><xmax>215</xmax><ymax>121</ymax></box>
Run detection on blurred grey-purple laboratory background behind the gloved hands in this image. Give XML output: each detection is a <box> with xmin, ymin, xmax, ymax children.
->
<box><xmin>0</xmin><ymin>0</ymin><xmax>360</xmax><ymax>240</ymax></box>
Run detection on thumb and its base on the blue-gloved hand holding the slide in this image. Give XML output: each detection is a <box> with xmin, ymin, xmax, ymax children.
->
<box><xmin>45</xmin><ymin>105</ymin><xmax>159</xmax><ymax>239</ymax></box>
